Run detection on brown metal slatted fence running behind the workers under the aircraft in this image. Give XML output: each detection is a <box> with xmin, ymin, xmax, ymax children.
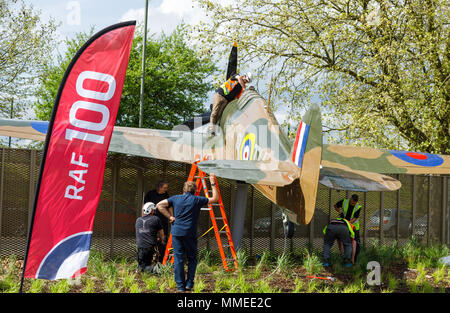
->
<box><xmin>0</xmin><ymin>148</ymin><xmax>450</xmax><ymax>258</ymax></box>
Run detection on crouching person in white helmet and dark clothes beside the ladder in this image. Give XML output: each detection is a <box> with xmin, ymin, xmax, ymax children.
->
<box><xmin>136</xmin><ymin>202</ymin><xmax>165</xmax><ymax>273</ymax></box>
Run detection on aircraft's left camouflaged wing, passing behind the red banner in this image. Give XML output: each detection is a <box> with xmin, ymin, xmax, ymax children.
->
<box><xmin>0</xmin><ymin>119</ymin><xmax>223</xmax><ymax>163</ymax></box>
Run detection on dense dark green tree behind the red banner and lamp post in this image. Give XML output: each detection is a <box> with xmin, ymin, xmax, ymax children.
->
<box><xmin>36</xmin><ymin>26</ymin><xmax>216</xmax><ymax>129</ymax></box>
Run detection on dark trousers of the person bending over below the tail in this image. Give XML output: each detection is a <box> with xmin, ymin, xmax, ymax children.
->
<box><xmin>323</xmin><ymin>224</ymin><xmax>352</xmax><ymax>263</ymax></box>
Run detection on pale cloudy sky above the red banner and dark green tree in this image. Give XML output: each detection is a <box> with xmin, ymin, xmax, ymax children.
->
<box><xmin>24</xmin><ymin>0</ymin><xmax>287</xmax><ymax>124</ymax></box>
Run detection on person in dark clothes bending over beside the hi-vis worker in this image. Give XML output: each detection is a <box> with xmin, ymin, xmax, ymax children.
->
<box><xmin>323</xmin><ymin>218</ymin><xmax>355</xmax><ymax>267</ymax></box>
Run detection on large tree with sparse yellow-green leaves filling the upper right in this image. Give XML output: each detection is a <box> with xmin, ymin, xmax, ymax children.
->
<box><xmin>195</xmin><ymin>0</ymin><xmax>450</xmax><ymax>154</ymax></box>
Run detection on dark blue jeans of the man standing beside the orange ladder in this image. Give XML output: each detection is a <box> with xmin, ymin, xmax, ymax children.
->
<box><xmin>172</xmin><ymin>236</ymin><xmax>197</xmax><ymax>289</ymax></box>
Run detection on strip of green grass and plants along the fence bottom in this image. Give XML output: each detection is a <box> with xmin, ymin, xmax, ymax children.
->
<box><xmin>0</xmin><ymin>239</ymin><xmax>450</xmax><ymax>293</ymax></box>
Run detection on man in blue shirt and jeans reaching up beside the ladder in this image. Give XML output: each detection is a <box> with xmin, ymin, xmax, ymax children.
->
<box><xmin>156</xmin><ymin>173</ymin><xmax>219</xmax><ymax>291</ymax></box>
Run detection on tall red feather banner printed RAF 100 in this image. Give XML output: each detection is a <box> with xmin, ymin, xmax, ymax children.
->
<box><xmin>22</xmin><ymin>21</ymin><xmax>135</xmax><ymax>283</ymax></box>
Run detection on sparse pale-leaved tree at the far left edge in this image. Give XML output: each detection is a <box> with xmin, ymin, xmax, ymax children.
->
<box><xmin>0</xmin><ymin>0</ymin><xmax>56</xmax><ymax>117</ymax></box>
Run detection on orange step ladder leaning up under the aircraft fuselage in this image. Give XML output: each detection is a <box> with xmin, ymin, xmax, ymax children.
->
<box><xmin>162</xmin><ymin>158</ymin><xmax>238</xmax><ymax>271</ymax></box>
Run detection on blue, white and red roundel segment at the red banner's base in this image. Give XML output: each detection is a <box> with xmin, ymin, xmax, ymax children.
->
<box><xmin>36</xmin><ymin>231</ymin><xmax>92</xmax><ymax>280</ymax></box>
